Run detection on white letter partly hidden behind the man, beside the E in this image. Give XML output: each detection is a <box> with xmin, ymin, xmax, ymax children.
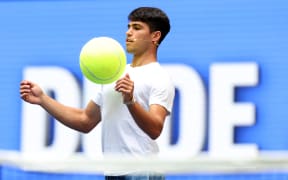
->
<box><xmin>158</xmin><ymin>64</ymin><xmax>206</xmax><ymax>157</ymax></box>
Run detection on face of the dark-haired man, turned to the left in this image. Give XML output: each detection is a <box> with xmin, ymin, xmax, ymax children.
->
<box><xmin>126</xmin><ymin>21</ymin><xmax>152</xmax><ymax>54</ymax></box>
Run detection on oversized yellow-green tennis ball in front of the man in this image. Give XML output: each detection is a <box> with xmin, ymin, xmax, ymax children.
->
<box><xmin>80</xmin><ymin>37</ymin><xmax>126</xmax><ymax>84</ymax></box>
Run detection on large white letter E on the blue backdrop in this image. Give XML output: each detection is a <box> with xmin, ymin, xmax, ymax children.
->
<box><xmin>209</xmin><ymin>63</ymin><xmax>258</xmax><ymax>159</ymax></box>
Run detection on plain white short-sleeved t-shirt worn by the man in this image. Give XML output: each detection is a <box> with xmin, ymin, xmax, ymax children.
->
<box><xmin>93</xmin><ymin>62</ymin><xmax>175</xmax><ymax>156</ymax></box>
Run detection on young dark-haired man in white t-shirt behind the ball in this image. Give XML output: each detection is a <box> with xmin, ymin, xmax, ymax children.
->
<box><xmin>20</xmin><ymin>7</ymin><xmax>175</xmax><ymax>179</ymax></box>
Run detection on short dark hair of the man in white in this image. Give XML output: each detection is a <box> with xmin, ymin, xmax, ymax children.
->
<box><xmin>128</xmin><ymin>7</ymin><xmax>170</xmax><ymax>44</ymax></box>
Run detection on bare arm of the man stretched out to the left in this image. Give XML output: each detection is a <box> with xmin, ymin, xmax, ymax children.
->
<box><xmin>20</xmin><ymin>81</ymin><xmax>101</xmax><ymax>133</ymax></box>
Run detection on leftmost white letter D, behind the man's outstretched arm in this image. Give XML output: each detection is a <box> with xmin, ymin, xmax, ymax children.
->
<box><xmin>21</xmin><ymin>66</ymin><xmax>81</xmax><ymax>157</ymax></box>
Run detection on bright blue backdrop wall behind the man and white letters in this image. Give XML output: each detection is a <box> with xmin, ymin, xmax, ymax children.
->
<box><xmin>0</xmin><ymin>0</ymin><xmax>288</xmax><ymax>153</ymax></box>
